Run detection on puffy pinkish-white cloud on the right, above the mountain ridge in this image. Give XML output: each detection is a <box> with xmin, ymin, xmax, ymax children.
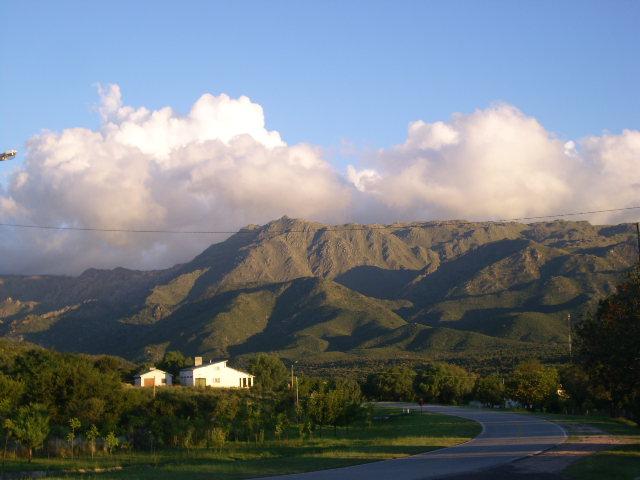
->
<box><xmin>349</xmin><ymin>104</ymin><xmax>640</xmax><ymax>221</ymax></box>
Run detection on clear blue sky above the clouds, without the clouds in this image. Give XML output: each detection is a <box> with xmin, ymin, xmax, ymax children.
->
<box><xmin>0</xmin><ymin>0</ymin><xmax>640</xmax><ymax>173</ymax></box>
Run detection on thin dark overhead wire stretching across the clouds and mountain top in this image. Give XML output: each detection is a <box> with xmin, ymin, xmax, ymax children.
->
<box><xmin>0</xmin><ymin>206</ymin><xmax>640</xmax><ymax>235</ymax></box>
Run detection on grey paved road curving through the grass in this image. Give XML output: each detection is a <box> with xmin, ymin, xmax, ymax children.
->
<box><xmin>255</xmin><ymin>403</ymin><xmax>567</xmax><ymax>480</ymax></box>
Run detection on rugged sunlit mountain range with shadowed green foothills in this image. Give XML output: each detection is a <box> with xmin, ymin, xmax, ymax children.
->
<box><xmin>0</xmin><ymin>217</ymin><xmax>636</xmax><ymax>363</ymax></box>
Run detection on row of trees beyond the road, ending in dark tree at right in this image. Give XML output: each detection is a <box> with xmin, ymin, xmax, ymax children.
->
<box><xmin>363</xmin><ymin>269</ymin><xmax>640</xmax><ymax>423</ymax></box>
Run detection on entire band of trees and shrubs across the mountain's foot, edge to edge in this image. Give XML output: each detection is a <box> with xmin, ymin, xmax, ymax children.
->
<box><xmin>0</xmin><ymin>271</ymin><xmax>640</xmax><ymax>462</ymax></box>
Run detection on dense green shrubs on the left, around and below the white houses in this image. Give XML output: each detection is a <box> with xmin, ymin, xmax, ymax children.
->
<box><xmin>0</xmin><ymin>349</ymin><xmax>365</xmax><ymax>458</ymax></box>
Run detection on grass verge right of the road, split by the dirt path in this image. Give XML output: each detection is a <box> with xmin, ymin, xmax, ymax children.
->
<box><xmin>545</xmin><ymin>415</ymin><xmax>640</xmax><ymax>480</ymax></box>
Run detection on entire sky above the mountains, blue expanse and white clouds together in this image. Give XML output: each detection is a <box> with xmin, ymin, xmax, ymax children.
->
<box><xmin>0</xmin><ymin>0</ymin><xmax>640</xmax><ymax>273</ymax></box>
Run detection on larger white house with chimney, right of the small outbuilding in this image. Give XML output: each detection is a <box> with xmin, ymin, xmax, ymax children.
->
<box><xmin>180</xmin><ymin>357</ymin><xmax>254</xmax><ymax>388</ymax></box>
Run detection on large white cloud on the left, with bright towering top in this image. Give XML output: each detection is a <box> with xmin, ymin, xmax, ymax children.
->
<box><xmin>0</xmin><ymin>85</ymin><xmax>351</xmax><ymax>273</ymax></box>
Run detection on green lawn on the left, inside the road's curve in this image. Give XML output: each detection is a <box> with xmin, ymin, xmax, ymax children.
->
<box><xmin>1</xmin><ymin>410</ymin><xmax>480</xmax><ymax>480</ymax></box>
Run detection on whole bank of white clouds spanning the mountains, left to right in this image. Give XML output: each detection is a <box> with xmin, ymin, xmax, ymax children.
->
<box><xmin>0</xmin><ymin>85</ymin><xmax>640</xmax><ymax>274</ymax></box>
